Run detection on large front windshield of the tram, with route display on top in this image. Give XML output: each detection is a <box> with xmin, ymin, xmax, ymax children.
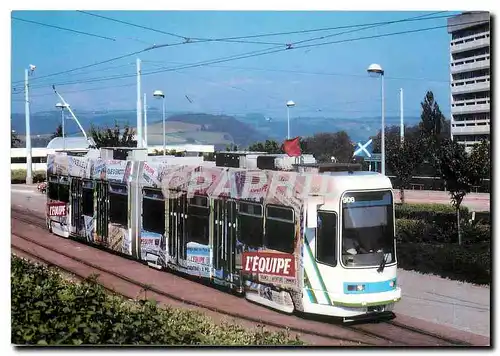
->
<box><xmin>341</xmin><ymin>190</ymin><xmax>396</xmax><ymax>267</ymax></box>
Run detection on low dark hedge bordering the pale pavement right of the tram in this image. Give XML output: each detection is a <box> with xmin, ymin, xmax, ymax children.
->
<box><xmin>397</xmin><ymin>242</ymin><xmax>491</xmax><ymax>284</ymax></box>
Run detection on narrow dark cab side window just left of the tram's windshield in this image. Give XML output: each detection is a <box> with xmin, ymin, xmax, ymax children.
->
<box><xmin>316</xmin><ymin>211</ymin><xmax>337</xmax><ymax>266</ymax></box>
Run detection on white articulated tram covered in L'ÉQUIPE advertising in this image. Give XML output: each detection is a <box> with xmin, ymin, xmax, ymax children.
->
<box><xmin>46</xmin><ymin>149</ymin><xmax>401</xmax><ymax>320</ymax></box>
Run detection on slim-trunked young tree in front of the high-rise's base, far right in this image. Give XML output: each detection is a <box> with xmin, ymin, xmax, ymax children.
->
<box><xmin>438</xmin><ymin>139</ymin><xmax>489</xmax><ymax>244</ymax></box>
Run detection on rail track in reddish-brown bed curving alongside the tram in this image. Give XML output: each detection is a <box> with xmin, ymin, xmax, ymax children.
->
<box><xmin>11</xmin><ymin>207</ymin><xmax>473</xmax><ymax>347</ymax></box>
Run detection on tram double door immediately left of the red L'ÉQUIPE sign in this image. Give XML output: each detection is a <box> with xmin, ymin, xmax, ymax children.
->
<box><xmin>212</xmin><ymin>199</ymin><xmax>239</xmax><ymax>283</ymax></box>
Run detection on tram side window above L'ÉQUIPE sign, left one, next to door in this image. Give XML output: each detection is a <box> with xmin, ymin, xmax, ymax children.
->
<box><xmin>238</xmin><ymin>202</ymin><xmax>264</xmax><ymax>247</ymax></box>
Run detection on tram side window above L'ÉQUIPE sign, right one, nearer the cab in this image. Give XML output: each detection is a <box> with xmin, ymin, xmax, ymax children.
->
<box><xmin>266</xmin><ymin>206</ymin><xmax>295</xmax><ymax>253</ymax></box>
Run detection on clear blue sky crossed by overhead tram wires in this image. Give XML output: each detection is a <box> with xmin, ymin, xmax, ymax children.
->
<box><xmin>11</xmin><ymin>11</ymin><xmax>456</xmax><ymax>118</ymax></box>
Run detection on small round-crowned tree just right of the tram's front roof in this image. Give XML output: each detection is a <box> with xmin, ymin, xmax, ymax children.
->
<box><xmin>386</xmin><ymin>137</ymin><xmax>423</xmax><ymax>204</ymax></box>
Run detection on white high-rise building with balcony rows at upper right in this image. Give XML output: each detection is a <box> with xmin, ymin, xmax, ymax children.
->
<box><xmin>448</xmin><ymin>11</ymin><xmax>490</xmax><ymax>149</ymax></box>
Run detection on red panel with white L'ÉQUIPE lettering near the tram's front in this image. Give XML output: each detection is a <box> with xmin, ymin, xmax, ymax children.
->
<box><xmin>242</xmin><ymin>252</ymin><xmax>295</xmax><ymax>277</ymax></box>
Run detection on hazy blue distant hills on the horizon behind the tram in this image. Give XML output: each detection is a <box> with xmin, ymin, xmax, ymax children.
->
<box><xmin>11</xmin><ymin>109</ymin><xmax>420</xmax><ymax>148</ymax></box>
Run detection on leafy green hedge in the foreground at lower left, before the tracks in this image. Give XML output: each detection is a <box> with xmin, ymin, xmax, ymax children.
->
<box><xmin>11</xmin><ymin>256</ymin><xmax>302</xmax><ymax>345</ymax></box>
